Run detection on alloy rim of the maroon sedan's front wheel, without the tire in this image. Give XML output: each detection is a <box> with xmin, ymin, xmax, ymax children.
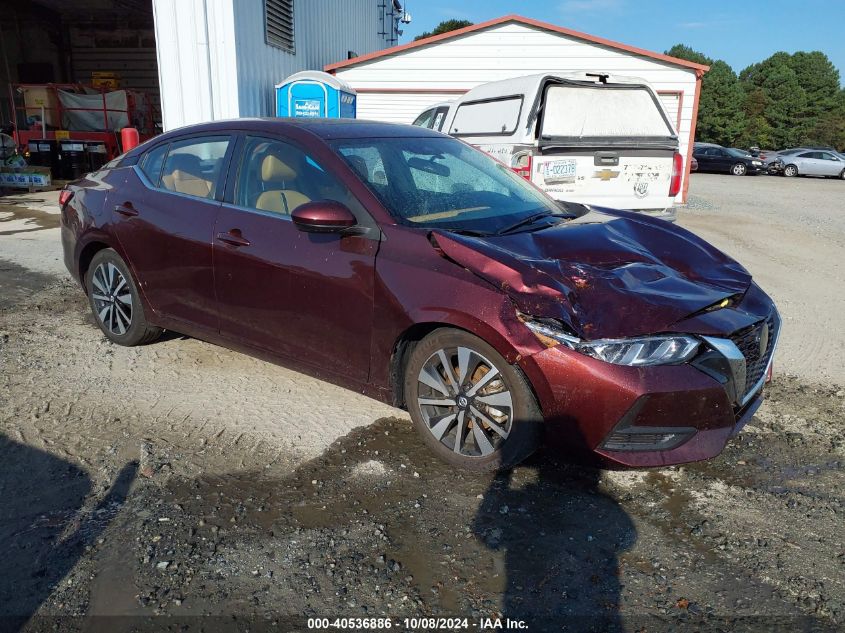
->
<box><xmin>417</xmin><ymin>347</ymin><xmax>513</xmax><ymax>457</ymax></box>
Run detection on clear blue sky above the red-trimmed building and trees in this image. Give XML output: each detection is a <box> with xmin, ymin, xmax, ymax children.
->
<box><xmin>399</xmin><ymin>0</ymin><xmax>845</xmax><ymax>79</ymax></box>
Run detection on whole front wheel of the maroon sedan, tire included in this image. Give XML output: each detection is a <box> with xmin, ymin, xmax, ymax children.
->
<box><xmin>404</xmin><ymin>328</ymin><xmax>542</xmax><ymax>472</ymax></box>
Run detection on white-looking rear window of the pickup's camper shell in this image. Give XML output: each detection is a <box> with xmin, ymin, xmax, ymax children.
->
<box><xmin>541</xmin><ymin>85</ymin><xmax>675</xmax><ymax>138</ymax></box>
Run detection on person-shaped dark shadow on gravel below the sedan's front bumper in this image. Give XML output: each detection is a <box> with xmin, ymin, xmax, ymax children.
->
<box><xmin>473</xmin><ymin>455</ymin><xmax>636</xmax><ymax>631</ymax></box>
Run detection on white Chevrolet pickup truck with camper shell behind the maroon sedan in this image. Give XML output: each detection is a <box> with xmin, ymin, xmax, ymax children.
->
<box><xmin>414</xmin><ymin>73</ymin><xmax>683</xmax><ymax>220</ymax></box>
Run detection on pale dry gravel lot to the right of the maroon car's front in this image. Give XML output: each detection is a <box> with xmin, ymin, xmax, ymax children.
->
<box><xmin>678</xmin><ymin>174</ymin><xmax>845</xmax><ymax>385</ymax></box>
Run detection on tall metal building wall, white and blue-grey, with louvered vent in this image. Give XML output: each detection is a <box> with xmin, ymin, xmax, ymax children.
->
<box><xmin>153</xmin><ymin>0</ymin><xmax>402</xmax><ymax>130</ymax></box>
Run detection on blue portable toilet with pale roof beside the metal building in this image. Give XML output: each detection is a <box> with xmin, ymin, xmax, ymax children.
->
<box><xmin>276</xmin><ymin>70</ymin><xmax>358</xmax><ymax>119</ymax></box>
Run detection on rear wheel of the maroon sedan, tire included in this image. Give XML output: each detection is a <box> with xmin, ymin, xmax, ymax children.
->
<box><xmin>85</xmin><ymin>248</ymin><xmax>161</xmax><ymax>346</ymax></box>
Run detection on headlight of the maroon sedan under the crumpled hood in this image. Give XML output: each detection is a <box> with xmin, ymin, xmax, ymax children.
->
<box><xmin>525</xmin><ymin>320</ymin><xmax>701</xmax><ymax>367</ymax></box>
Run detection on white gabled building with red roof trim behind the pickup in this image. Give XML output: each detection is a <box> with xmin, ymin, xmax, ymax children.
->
<box><xmin>325</xmin><ymin>15</ymin><xmax>708</xmax><ymax>202</ymax></box>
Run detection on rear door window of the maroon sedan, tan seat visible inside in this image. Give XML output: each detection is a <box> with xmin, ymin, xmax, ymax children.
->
<box><xmin>161</xmin><ymin>136</ymin><xmax>229</xmax><ymax>198</ymax></box>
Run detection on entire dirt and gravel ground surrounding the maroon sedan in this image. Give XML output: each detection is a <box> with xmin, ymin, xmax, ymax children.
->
<box><xmin>0</xmin><ymin>174</ymin><xmax>845</xmax><ymax>632</ymax></box>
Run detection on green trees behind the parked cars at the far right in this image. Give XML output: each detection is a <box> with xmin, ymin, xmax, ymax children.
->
<box><xmin>666</xmin><ymin>44</ymin><xmax>845</xmax><ymax>151</ymax></box>
